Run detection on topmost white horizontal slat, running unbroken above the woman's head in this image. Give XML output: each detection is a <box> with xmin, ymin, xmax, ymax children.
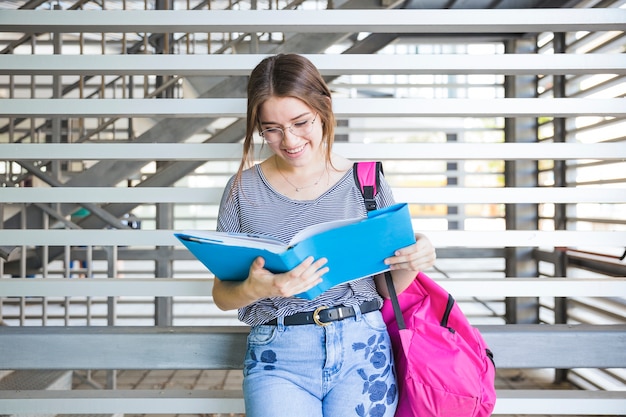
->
<box><xmin>0</xmin><ymin>8</ymin><xmax>626</xmax><ymax>33</ymax></box>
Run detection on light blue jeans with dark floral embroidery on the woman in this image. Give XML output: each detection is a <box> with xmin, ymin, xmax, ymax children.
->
<box><xmin>243</xmin><ymin>311</ymin><xmax>398</xmax><ymax>417</ymax></box>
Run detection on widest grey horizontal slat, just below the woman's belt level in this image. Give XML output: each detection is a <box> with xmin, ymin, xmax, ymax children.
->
<box><xmin>0</xmin><ymin>324</ymin><xmax>626</xmax><ymax>368</ymax></box>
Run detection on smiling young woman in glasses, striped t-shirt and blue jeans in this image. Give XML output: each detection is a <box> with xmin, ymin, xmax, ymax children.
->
<box><xmin>213</xmin><ymin>54</ymin><xmax>435</xmax><ymax>417</ymax></box>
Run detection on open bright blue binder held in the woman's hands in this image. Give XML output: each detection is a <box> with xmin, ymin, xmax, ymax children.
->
<box><xmin>175</xmin><ymin>203</ymin><xmax>415</xmax><ymax>300</ymax></box>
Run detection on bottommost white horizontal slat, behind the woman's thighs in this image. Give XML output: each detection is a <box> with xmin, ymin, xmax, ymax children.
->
<box><xmin>0</xmin><ymin>390</ymin><xmax>626</xmax><ymax>415</ymax></box>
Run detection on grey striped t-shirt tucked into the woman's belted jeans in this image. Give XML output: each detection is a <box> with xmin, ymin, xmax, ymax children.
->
<box><xmin>217</xmin><ymin>165</ymin><xmax>394</xmax><ymax>326</ymax></box>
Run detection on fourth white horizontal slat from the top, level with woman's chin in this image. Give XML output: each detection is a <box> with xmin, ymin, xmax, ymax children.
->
<box><xmin>0</xmin><ymin>142</ymin><xmax>626</xmax><ymax>161</ymax></box>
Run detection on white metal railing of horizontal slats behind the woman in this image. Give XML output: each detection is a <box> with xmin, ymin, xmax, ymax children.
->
<box><xmin>0</xmin><ymin>4</ymin><xmax>626</xmax><ymax>415</ymax></box>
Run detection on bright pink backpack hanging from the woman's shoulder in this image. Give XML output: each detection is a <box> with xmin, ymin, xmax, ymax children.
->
<box><xmin>354</xmin><ymin>162</ymin><xmax>496</xmax><ymax>417</ymax></box>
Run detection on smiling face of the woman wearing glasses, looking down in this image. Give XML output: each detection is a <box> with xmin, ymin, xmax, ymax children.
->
<box><xmin>259</xmin><ymin>97</ymin><xmax>323</xmax><ymax>166</ymax></box>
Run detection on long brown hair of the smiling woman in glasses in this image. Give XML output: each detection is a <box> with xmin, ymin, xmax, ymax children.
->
<box><xmin>235</xmin><ymin>54</ymin><xmax>335</xmax><ymax>184</ymax></box>
